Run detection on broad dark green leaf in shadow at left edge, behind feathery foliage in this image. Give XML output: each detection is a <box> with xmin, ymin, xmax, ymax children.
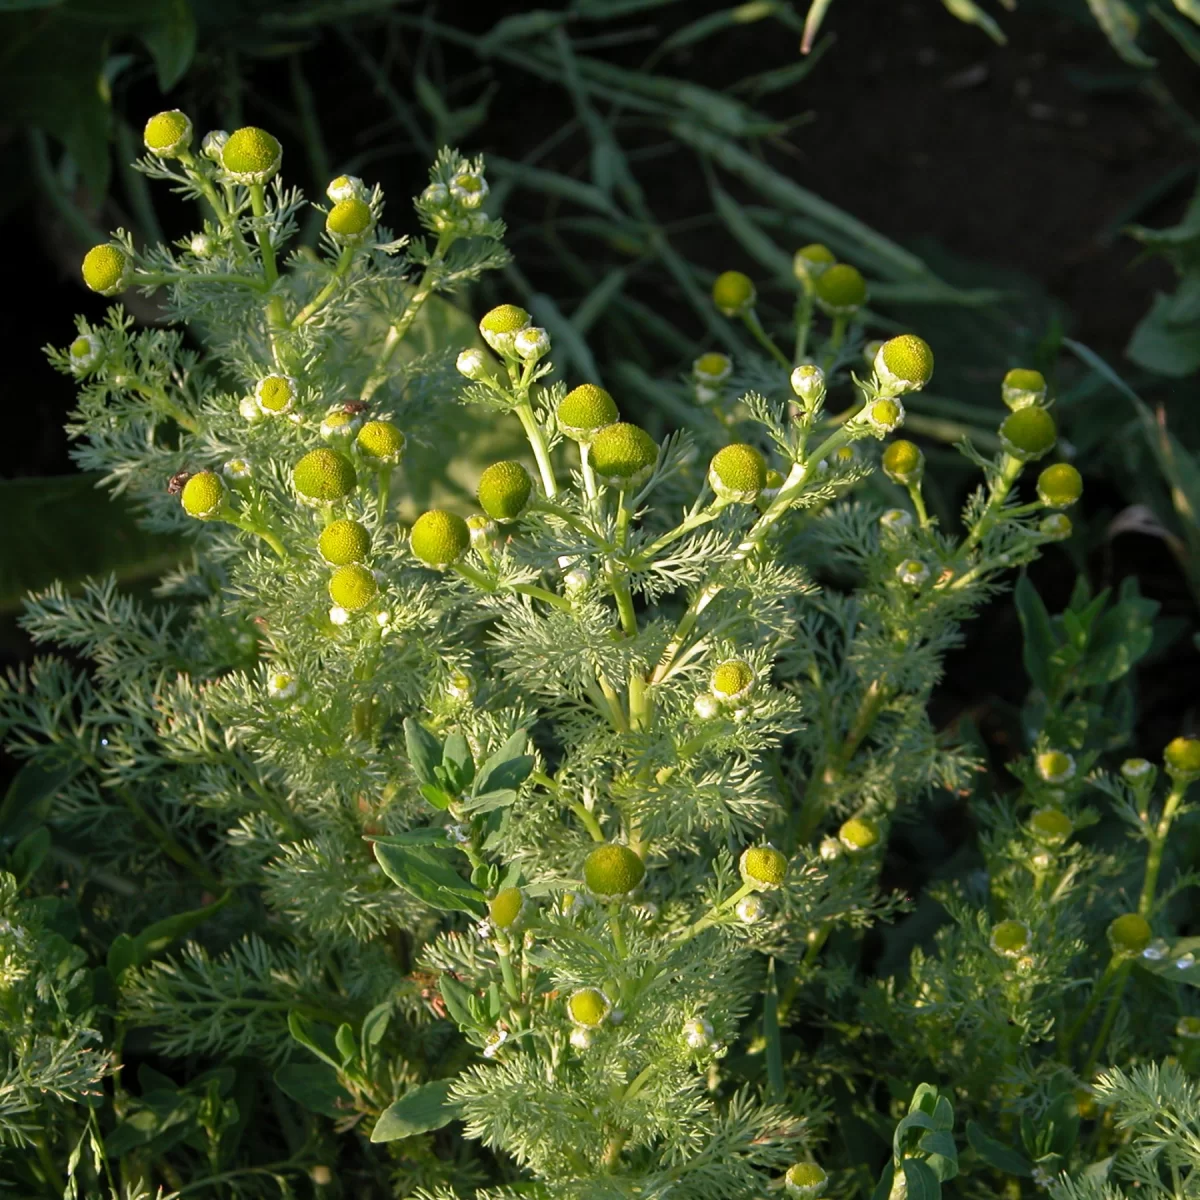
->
<box><xmin>0</xmin><ymin>472</ymin><xmax>187</xmax><ymax>611</ymax></box>
